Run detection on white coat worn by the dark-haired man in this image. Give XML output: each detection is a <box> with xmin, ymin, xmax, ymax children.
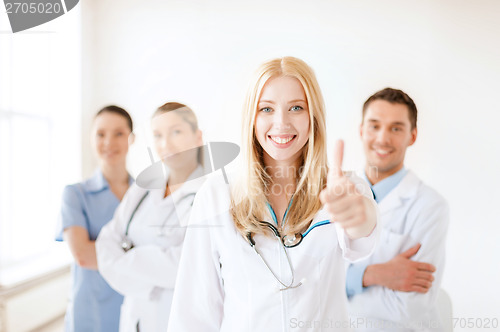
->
<box><xmin>349</xmin><ymin>171</ymin><xmax>449</xmax><ymax>331</ymax></box>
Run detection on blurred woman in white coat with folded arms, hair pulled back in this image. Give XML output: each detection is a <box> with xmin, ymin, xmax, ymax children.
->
<box><xmin>96</xmin><ymin>103</ymin><xmax>204</xmax><ymax>332</ymax></box>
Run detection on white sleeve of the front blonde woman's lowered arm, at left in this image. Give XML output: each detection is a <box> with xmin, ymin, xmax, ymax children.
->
<box><xmin>168</xmin><ymin>181</ymin><xmax>224</xmax><ymax>332</ymax></box>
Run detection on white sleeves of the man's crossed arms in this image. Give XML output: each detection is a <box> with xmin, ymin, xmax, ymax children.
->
<box><xmin>350</xmin><ymin>198</ymin><xmax>449</xmax><ymax>322</ymax></box>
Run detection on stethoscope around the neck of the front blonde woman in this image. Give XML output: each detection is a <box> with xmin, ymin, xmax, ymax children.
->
<box><xmin>247</xmin><ymin>197</ymin><xmax>330</xmax><ymax>291</ymax></box>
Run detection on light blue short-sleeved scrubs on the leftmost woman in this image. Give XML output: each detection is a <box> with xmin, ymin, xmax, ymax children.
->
<box><xmin>56</xmin><ymin>170</ymin><xmax>133</xmax><ymax>332</ymax></box>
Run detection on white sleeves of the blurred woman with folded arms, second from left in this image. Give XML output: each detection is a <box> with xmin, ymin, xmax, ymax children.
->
<box><xmin>96</xmin><ymin>185</ymin><xmax>186</xmax><ymax>297</ymax></box>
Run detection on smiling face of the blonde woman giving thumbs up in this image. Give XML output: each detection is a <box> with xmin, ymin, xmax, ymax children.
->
<box><xmin>255</xmin><ymin>76</ymin><xmax>310</xmax><ymax>166</ymax></box>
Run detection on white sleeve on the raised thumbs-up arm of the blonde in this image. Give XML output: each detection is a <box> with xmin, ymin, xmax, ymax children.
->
<box><xmin>335</xmin><ymin>172</ymin><xmax>380</xmax><ymax>262</ymax></box>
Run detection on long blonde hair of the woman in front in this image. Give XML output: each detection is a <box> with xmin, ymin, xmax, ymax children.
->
<box><xmin>231</xmin><ymin>57</ymin><xmax>328</xmax><ymax>236</ymax></box>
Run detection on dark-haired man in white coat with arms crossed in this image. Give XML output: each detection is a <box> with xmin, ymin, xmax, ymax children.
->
<box><xmin>346</xmin><ymin>88</ymin><xmax>449</xmax><ymax>331</ymax></box>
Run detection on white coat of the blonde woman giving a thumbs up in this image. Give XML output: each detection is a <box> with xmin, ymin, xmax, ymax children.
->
<box><xmin>168</xmin><ymin>174</ymin><xmax>378</xmax><ymax>332</ymax></box>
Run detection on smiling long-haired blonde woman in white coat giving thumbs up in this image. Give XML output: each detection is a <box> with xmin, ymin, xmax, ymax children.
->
<box><xmin>168</xmin><ymin>57</ymin><xmax>377</xmax><ymax>332</ymax></box>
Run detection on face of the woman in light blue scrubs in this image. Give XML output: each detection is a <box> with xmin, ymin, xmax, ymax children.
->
<box><xmin>91</xmin><ymin>112</ymin><xmax>130</xmax><ymax>166</ymax></box>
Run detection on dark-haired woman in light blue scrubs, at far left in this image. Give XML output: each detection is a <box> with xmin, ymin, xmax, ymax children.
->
<box><xmin>56</xmin><ymin>105</ymin><xmax>134</xmax><ymax>332</ymax></box>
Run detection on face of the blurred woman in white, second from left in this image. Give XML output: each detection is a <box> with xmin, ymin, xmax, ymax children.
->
<box><xmin>151</xmin><ymin>111</ymin><xmax>203</xmax><ymax>170</ymax></box>
